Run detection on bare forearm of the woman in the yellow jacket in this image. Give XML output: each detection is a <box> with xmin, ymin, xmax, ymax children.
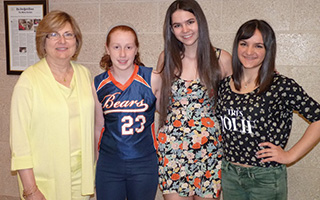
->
<box><xmin>18</xmin><ymin>169</ymin><xmax>46</xmax><ymax>200</ymax></box>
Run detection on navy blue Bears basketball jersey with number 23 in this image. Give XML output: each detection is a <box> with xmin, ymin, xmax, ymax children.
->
<box><xmin>94</xmin><ymin>65</ymin><xmax>157</xmax><ymax>159</ymax></box>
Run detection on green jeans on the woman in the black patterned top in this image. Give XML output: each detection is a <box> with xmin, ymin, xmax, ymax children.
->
<box><xmin>221</xmin><ymin>160</ymin><xmax>288</xmax><ymax>200</ymax></box>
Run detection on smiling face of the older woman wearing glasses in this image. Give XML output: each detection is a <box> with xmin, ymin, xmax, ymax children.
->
<box><xmin>45</xmin><ymin>23</ymin><xmax>77</xmax><ymax>61</ymax></box>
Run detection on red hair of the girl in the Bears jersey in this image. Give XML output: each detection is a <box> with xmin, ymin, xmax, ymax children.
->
<box><xmin>100</xmin><ymin>25</ymin><xmax>144</xmax><ymax>71</ymax></box>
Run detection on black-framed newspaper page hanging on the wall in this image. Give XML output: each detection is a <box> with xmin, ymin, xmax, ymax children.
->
<box><xmin>4</xmin><ymin>0</ymin><xmax>48</xmax><ymax>74</ymax></box>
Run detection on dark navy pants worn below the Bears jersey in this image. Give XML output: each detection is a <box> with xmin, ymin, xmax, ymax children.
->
<box><xmin>96</xmin><ymin>153</ymin><xmax>158</xmax><ymax>200</ymax></box>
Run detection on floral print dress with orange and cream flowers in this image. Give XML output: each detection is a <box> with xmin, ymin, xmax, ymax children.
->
<box><xmin>158</xmin><ymin>78</ymin><xmax>222</xmax><ymax>198</ymax></box>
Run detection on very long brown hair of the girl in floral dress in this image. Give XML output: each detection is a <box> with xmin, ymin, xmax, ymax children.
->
<box><xmin>160</xmin><ymin>0</ymin><xmax>221</xmax><ymax>126</ymax></box>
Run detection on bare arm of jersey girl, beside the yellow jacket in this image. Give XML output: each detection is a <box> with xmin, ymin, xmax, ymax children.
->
<box><xmin>92</xmin><ymin>83</ymin><xmax>104</xmax><ymax>160</ymax></box>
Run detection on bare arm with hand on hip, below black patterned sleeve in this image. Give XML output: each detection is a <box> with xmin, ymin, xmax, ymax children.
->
<box><xmin>257</xmin><ymin>120</ymin><xmax>320</xmax><ymax>164</ymax></box>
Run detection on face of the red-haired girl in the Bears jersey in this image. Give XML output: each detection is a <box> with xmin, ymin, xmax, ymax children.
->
<box><xmin>106</xmin><ymin>30</ymin><xmax>138</xmax><ymax>70</ymax></box>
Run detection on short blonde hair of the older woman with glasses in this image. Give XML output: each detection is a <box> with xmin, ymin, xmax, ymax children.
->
<box><xmin>36</xmin><ymin>10</ymin><xmax>82</xmax><ymax>60</ymax></box>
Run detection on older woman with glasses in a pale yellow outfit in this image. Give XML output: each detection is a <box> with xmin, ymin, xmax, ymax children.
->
<box><xmin>10</xmin><ymin>11</ymin><xmax>94</xmax><ymax>200</ymax></box>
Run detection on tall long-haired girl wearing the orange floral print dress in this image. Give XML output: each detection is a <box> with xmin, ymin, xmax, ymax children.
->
<box><xmin>158</xmin><ymin>0</ymin><xmax>231</xmax><ymax>200</ymax></box>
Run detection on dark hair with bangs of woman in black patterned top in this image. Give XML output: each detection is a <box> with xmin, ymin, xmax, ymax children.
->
<box><xmin>232</xmin><ymin>19</ymin><xmax>277</xmax><ymax>94</ymax></box>
